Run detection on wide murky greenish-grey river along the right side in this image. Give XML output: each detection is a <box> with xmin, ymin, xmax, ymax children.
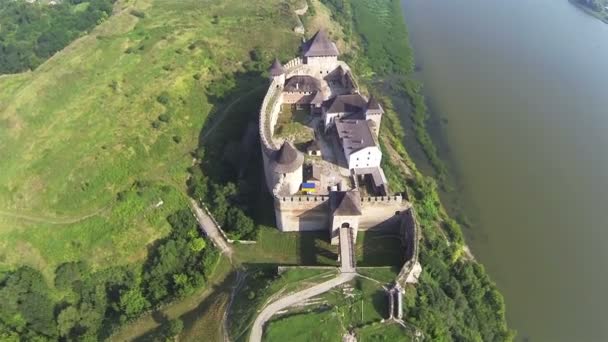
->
<box><xmin>403</xmin><ymin>0</ymin><xmax>608</xmax><ymax>341</ymax></box>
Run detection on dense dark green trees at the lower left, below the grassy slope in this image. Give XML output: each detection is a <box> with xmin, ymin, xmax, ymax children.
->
<box><xmin>0</xmin><ymin>184</ymin><xmax>219</xmax><ymax>341</ymax></box>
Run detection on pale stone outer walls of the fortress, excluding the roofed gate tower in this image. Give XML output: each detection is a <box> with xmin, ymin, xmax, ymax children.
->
<box><xmin>259</xmin><ymin>37</ymin><xmax>410</xmax><ymax>231</ymax></box>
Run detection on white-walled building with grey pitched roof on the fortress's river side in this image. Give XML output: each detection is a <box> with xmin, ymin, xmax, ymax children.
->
<box><xmin>336</xmin><ymin>120</ymin><xmax>382</xmax><ymax>170</ymax></box>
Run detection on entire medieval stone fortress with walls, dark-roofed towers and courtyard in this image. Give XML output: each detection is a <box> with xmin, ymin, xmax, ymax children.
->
<box><xmin>259</xmin><ymin>31</ymin><xmax>411</xmax><ymax>244</ymax></box>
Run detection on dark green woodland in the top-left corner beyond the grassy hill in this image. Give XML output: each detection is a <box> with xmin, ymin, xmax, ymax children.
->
<box><xmin>0</xmin><ymin>0</ymin><xmax>115</xmax><ymax>75</ymax></box>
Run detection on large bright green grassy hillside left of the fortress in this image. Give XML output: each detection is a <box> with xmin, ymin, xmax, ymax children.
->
<box><xmin>0</xmin><ymin>0</ymin><xmax>297</xmax><ymax>276</ymax></box>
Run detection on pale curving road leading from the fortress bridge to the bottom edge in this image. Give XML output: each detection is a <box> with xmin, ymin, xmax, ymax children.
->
<box><xmin>249</xmin><ymin>273</ymin><xmax>357</xmax><ymax>342</ymax></box>
